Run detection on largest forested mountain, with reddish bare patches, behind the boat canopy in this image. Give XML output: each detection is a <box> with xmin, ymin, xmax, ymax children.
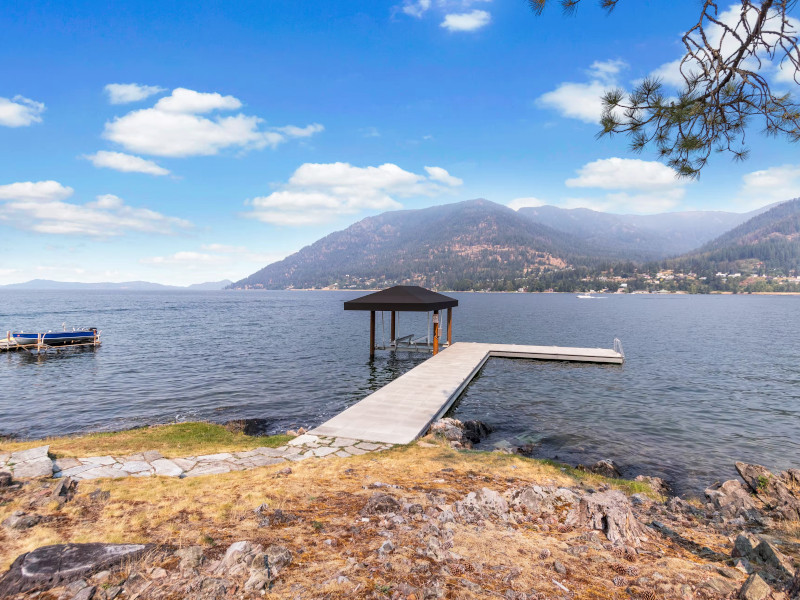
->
<box><xmin>232</xmin><ymin>199</ymin><xmax>620</xmax><ymax>289</ymax></box>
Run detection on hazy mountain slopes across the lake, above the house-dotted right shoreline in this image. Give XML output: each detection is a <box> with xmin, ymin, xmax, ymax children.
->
<box><xmin>231</xmin><ymin>199</ymin><xmax>800</xmax><ymax>289</ymax></box>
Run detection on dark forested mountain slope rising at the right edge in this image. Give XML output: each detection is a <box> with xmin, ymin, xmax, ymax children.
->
<box><xmin>671</xmin><ymin>198</ymin><xmax>800</xmax><ymax>275</ymax></box>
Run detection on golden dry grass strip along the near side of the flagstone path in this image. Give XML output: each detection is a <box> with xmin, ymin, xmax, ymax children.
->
<box><xmin>0</xmin><ymin>446</ymin><xmax>575</xmax><ymax>567</ymax></box>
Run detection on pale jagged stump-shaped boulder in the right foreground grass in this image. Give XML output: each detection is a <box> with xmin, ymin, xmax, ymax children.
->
<box><xmin>566</xmin><ymin>490</ymin><xmax>647</xmax><ymax>546</ymax></box>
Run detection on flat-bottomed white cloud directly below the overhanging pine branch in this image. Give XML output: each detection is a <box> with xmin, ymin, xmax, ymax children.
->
<box><xmin>565</xmin><ymin>158</ymin><xmax>688</xmax><ymax>190</ymax></box>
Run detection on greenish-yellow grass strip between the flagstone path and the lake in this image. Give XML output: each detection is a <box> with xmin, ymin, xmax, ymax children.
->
<box><xmin>0</xmin><ymin>423</ymin><xmax>291</xmax><ymax>458</ymax></box>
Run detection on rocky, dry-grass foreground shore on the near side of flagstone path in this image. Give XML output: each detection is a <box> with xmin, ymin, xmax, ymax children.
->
<box><xmin>0</xmin><ymin>420</ymin><xmax>800</xmax><ymax>600</ymax></box>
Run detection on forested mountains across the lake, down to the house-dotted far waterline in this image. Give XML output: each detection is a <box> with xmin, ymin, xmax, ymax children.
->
<box><xmin>231</xmin><ymin>199</ymin><xmax>800</xmax><ymax>292</ymax></box>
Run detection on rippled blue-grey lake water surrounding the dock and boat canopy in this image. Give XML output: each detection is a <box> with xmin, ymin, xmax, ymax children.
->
<box><xmin>0</xmin><ymin>291</ymin><xmax>800</xmax><ymax>492</ymax></box>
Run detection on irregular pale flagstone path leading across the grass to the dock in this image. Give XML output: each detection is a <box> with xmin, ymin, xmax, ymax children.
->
<box><xmin>0</xmin><ymin>434</ymin><xmax>391</xmax><ymax>480</ymax></box>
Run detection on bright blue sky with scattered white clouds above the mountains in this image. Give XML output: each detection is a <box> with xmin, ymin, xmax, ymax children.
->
<box><xmin>0</xmin><ymin>0</ymin><xmax>800</xmax><ymax>285</ymax></box>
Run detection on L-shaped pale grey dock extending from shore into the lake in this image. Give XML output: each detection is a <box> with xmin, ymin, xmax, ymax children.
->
<box><xmin>309</xmin><ymin>342</ymin><xmax>625</xmax><ymax>444</ymax></box>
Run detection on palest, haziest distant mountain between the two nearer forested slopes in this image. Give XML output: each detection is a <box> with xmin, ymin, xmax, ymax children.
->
<box><xmin>519</xmin><ymin>206</ymin><xmax>769</xmax><ymax>260</ymax></box>
